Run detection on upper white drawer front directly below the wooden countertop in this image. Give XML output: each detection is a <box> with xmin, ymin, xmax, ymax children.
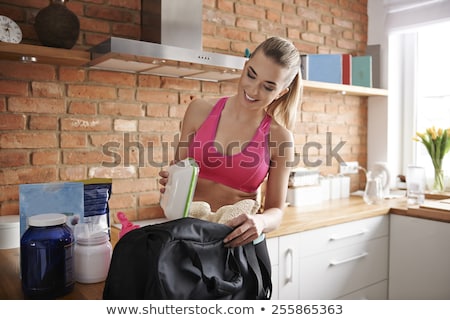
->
<box><xmin>299</xmin><ymin>215</ymin><xmax>389</xmax><ymax>257</ymax></box>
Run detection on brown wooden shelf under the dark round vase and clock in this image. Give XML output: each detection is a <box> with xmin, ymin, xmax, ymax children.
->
<box><xmin>0</xmin><ymin>42</ymin><xmax>90</xmax><ymax>66</ymax></box>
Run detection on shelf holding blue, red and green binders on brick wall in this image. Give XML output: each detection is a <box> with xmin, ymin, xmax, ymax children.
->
<box><xmin>303</xmin><ymin>80</ymin><xmax>388</xmax><ymax>97</ymax></box>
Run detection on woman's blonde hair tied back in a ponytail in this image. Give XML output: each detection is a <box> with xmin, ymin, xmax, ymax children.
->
<box><xmin>253</xmin><ymin>37</ymin><xmax>303</xmax><ymax>131</ymax></box>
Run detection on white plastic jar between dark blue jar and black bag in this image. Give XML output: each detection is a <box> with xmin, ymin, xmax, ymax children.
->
<box><xmin>75</xmin><ymin>232</ymin><xmax>112</xmax><ymax>283</ymax></box>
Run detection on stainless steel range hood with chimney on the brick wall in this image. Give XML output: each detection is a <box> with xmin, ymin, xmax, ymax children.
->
<box><xmin>90</xmin><ymin>0</ymin><xmax>246</xmax><ymax>81</ymax></box>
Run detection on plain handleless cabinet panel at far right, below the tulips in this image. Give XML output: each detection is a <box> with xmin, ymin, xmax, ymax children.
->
<box><xmin>389</xmin><ymin>214</ymin><xmax>450</xmax><ymax>300</ymax></box>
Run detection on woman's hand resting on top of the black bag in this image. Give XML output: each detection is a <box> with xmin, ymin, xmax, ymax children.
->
<box><xmin>223</xmin><ymin>214</ymin><xmax>264</xmax><ymax>247</ymax></box>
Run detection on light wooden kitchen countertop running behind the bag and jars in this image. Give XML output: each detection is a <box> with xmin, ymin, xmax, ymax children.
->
<box><xmin>0</xmin><ymin>196</ymin><xmax>450</xmax><ymax>300</ymax></box>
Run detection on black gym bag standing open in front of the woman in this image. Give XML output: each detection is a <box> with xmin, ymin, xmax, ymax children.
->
<box><xmin>103</xmin><ymin>218</ymin><xmax>272</xmax><ymax>300</ymax></box>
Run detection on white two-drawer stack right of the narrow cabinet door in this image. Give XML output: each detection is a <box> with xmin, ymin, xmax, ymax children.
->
<box><xmin>299</xmin><ymin>216</ymin><xmax>389</xmax><ymax>300</ymax></box>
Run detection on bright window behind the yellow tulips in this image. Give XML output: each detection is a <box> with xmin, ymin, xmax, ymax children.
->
<box><xmin>388</xmin><ymin>21</ymin><xmax>450</xmax><ymax>190</ymax></box>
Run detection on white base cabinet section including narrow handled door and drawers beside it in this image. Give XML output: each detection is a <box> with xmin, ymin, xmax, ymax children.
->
<box><xmin>270</xmin><ymin>215</ymin><xmax>389</xmax><ymax>300</ymax></box>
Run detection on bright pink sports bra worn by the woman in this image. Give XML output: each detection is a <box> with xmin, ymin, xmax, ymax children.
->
<box><xmin>189</xmin><ymin>97</ymin><xmax>272</xmax><ymax>193</ymax></box>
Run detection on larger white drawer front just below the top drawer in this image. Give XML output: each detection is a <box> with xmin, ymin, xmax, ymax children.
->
<box><xmin>299</xmin><ymin>237</ymin><xmax>389</xmax><ymax>300</ymax></box>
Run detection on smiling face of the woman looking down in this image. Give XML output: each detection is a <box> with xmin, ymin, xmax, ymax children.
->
<box><xmin>238</xmin><ymin>51</ymin><xmax>288</xmax><ymax>108</ymax></box>
